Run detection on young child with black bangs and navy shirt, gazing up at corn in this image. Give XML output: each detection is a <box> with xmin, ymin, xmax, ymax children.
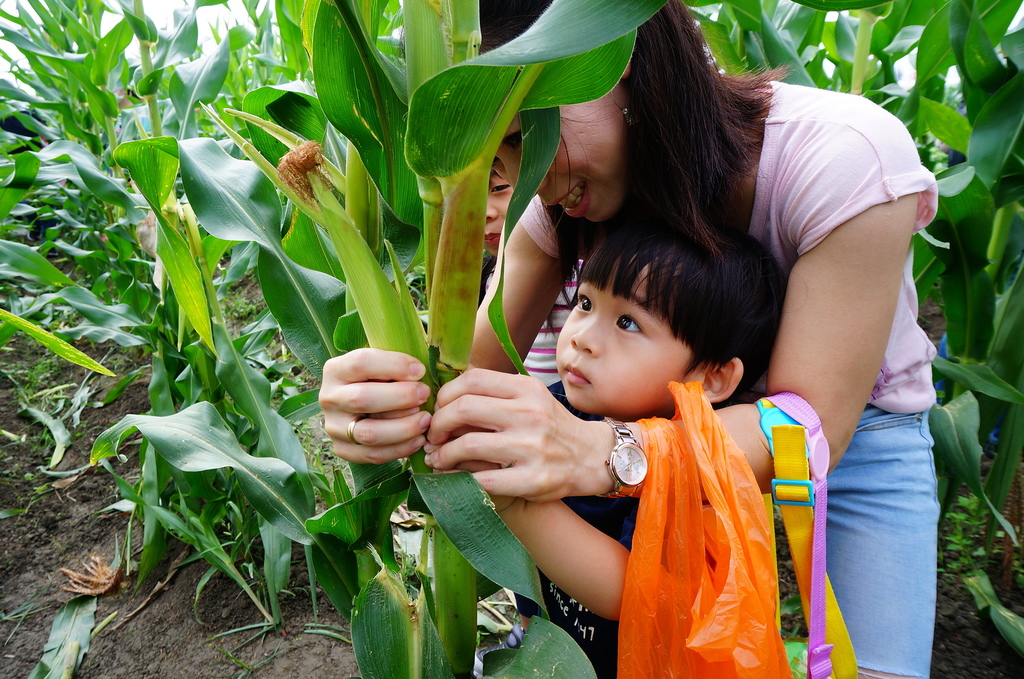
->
<box><xmin>494</xmin><ymin>221</ymin><xmax>783</xmax><ymax>679</ymax></box>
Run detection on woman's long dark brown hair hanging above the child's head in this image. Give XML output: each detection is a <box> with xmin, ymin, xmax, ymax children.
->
<box><xmin>480</xmin><ymin>0</ymin><xmax>778</xmax><ymax>272</ymax></box>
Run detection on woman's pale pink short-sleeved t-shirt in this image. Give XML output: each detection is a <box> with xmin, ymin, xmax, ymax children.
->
<box><xmin>522</xmin><ymin>77</ymin><xmax>938</xmax><ymax>413</ymax></box>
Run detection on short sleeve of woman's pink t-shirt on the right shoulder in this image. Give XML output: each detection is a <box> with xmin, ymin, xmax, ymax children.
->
<box><xmin>750</xmin><ymin>83</ymin><xmax>938</xmax><ymax>271</ymax></box>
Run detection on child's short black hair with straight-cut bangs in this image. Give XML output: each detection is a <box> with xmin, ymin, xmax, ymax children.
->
<box><xmin>580</xmin><ymin>218</ymin><xmax>784</xmax><ymax>394</ymax></box>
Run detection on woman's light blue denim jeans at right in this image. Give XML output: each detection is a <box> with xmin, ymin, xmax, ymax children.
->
<box><xmin>827</xmin><ymin>406</ymin><xmax>939</xmax><ymax>677</ymax></box>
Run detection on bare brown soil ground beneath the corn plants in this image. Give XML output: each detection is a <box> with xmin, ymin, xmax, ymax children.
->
<box><xmin>0</xmin><ymin>303</ymin><xmax>1024</xmax><ymax>679</ymax></box>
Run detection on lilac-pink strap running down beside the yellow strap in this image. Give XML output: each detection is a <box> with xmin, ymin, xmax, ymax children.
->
<box><xmin>768</xmin><ymin>391</ymin><xmax>833</xmax><ymax>679</ymax></box>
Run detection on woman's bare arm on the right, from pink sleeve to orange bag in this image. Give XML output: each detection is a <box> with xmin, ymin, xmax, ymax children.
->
<box><xmin>719</xmin><ymin>194</ymin><xmax>918</xmax><ymax>490</ymax></box>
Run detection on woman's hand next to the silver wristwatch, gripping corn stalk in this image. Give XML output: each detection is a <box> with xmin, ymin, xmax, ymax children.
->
<box><xmin>426</xmin><ymin>369</ymin><xmax>613</xmax><ymax>502</ymax></box>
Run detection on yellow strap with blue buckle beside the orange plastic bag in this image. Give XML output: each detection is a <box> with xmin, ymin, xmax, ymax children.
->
<box><xmin>772</xmin><ymin>425</ymin><xmax>857</xmax><ymax>679</ymax></box>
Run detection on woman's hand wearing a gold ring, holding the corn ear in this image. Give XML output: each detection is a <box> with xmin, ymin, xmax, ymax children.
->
<box><xmin>319</xmin><ymin>349</ymin><xmax>430</xmax><ymax>464</ymax></box>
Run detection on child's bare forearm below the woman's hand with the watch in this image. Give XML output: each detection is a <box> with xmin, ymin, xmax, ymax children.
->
<box><xmin>493</xmin><ymin>497</ymin><xmax>630</xmax><ymax>620</ymax></box>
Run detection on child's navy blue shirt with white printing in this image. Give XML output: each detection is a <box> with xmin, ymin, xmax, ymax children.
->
<box><xmin>516</xmin><ymin>382</ymin><xmax>640</xmax><ymax>679</ymax></box>
